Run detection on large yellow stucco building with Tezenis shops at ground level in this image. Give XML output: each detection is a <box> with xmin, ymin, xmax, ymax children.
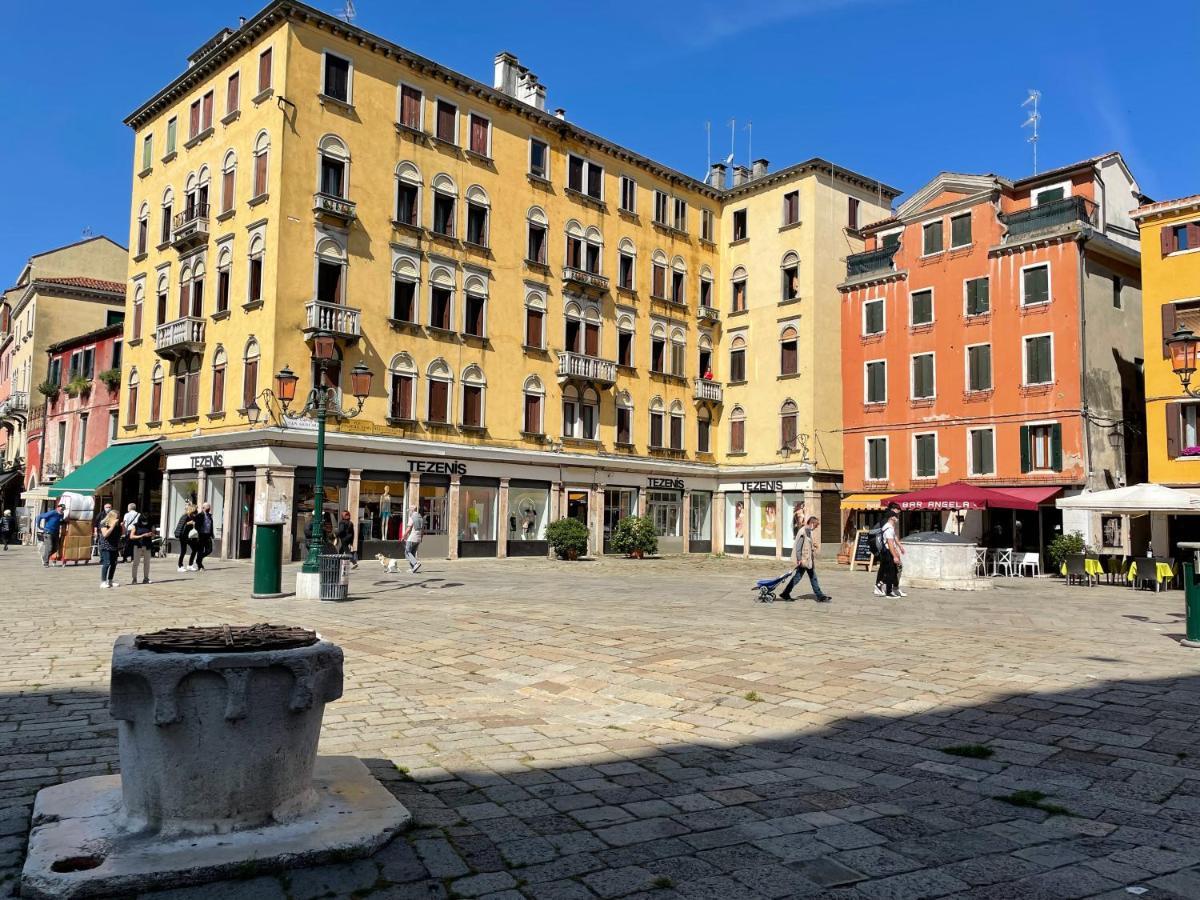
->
<box><xmin>121</xmin><ymin>0</ymin><xmax>898</xmax><ymax>558</ymax></box>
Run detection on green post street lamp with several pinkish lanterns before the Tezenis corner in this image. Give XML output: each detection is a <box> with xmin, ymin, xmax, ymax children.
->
<box><xmin>274</xmin><ymin>334</ymin><xmax>374</xmax><ymax>575</ymax></box>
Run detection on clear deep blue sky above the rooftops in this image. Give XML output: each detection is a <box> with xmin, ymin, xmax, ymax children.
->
<box><xmin>0</xmin><ymin>0</ymin><xmax>1200</xmax><ymax>286</ymax></box>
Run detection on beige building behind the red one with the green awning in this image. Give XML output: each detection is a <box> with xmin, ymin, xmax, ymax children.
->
<box><xmin>0</xmin><ymin>236</ymin><xmax>128</xmax><ymax>500</ymax></box>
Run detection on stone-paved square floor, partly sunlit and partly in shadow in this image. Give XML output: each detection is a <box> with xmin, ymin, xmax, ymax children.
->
<box><xmin>0</xmin><ymin>548</ymin><xmax>1200</xmax><ymax>900</ymax></box>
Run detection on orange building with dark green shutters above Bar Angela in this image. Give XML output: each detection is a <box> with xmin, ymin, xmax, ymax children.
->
<box><xmin>839</xmin><ymin>154</ymin><xmax>1145</xmax><ymax>551</ymax></box>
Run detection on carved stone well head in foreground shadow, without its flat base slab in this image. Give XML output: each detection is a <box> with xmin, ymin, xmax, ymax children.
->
<box><xmin>112</xmin><ymin>625</ymin><xmax>342</xmax><ymax>834</ymax></box>
